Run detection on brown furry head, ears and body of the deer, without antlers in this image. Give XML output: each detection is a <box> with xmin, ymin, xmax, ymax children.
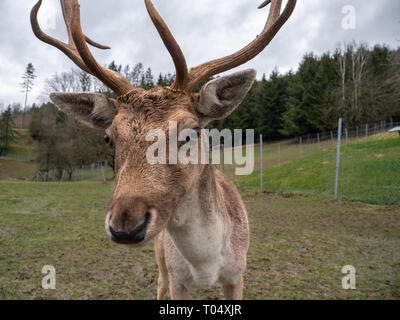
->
<box><xmin>51</xmin><ymin>70</ymin><xmax>255</xmax><ymax>299</ymax></box>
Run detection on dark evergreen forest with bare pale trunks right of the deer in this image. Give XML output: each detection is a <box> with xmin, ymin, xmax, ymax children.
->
<box><xmin>213</xmin><ymin>42</ymin><xmax>400</xmax><ymax>140</ymax></box>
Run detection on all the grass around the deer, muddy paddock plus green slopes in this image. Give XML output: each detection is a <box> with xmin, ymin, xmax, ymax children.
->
<box><xmin>0</xmin><ymin>131</ymin><xmax>400</xmax><ymax>299</ymax></box>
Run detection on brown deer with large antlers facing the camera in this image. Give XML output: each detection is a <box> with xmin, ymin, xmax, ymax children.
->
<box><xmin>30</xmin><ymin>0</ymin><xmax>296</xmax><ymax>300</ymax></box>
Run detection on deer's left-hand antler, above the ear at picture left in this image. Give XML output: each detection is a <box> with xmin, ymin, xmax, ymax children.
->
<box><xmin>31</xmin><ymin>0</ymin><xmax>134</xmax><ymax>96</ymax></box>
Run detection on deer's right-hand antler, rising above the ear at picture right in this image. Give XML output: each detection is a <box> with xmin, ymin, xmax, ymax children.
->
<box><xmin>145</xmin><ymin>0</ymin><xmax>297</xmax><ymax>92</ymax></box>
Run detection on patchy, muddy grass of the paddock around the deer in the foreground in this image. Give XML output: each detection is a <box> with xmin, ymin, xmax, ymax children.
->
<box><xmin>0</xmin><ymin>181</ymin><xmax>400</xmax><ymax>299</ymax></box>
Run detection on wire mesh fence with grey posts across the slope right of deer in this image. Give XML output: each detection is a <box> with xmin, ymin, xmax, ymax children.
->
<box><xmin>218</xmin><ymin>121</ymin><xmax>400</xmax><ymax>204</ymax></box>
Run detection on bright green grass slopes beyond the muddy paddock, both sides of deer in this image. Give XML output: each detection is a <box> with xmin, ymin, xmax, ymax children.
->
<box><xmin>0</xmin><ymin>130</ymin><xmax>400</xmax><ymax>204</ymax></box>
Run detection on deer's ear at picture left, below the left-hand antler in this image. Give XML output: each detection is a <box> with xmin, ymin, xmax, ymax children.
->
<box><xmin>50</xmin><ymin>92</ymin><xmax>117</xmax><ymax>129</ymax></box>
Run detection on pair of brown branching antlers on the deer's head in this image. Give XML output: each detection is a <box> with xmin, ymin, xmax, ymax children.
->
<box><xmin>31</xmin><ymin>0</ymin><xmax>297</xmax><ymax>96</ymax></box>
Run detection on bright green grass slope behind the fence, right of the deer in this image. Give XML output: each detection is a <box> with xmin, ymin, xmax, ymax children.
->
<box><xmin>219</xmin><ymin>133</ymin><xmax>400</xmax><ymax>204</ymax></box>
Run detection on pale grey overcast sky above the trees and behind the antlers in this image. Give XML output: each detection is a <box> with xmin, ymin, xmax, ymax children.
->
<box><xmin>0</xmin><ymin>0</ymin><xmax>400</xmax><ymax>107</ymax></box>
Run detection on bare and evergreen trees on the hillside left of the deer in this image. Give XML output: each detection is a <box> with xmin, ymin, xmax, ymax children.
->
<box><xmin>0</xmin><ymin>62</ymin><xmax>174</xmax><ymax>180</ymax></box>
